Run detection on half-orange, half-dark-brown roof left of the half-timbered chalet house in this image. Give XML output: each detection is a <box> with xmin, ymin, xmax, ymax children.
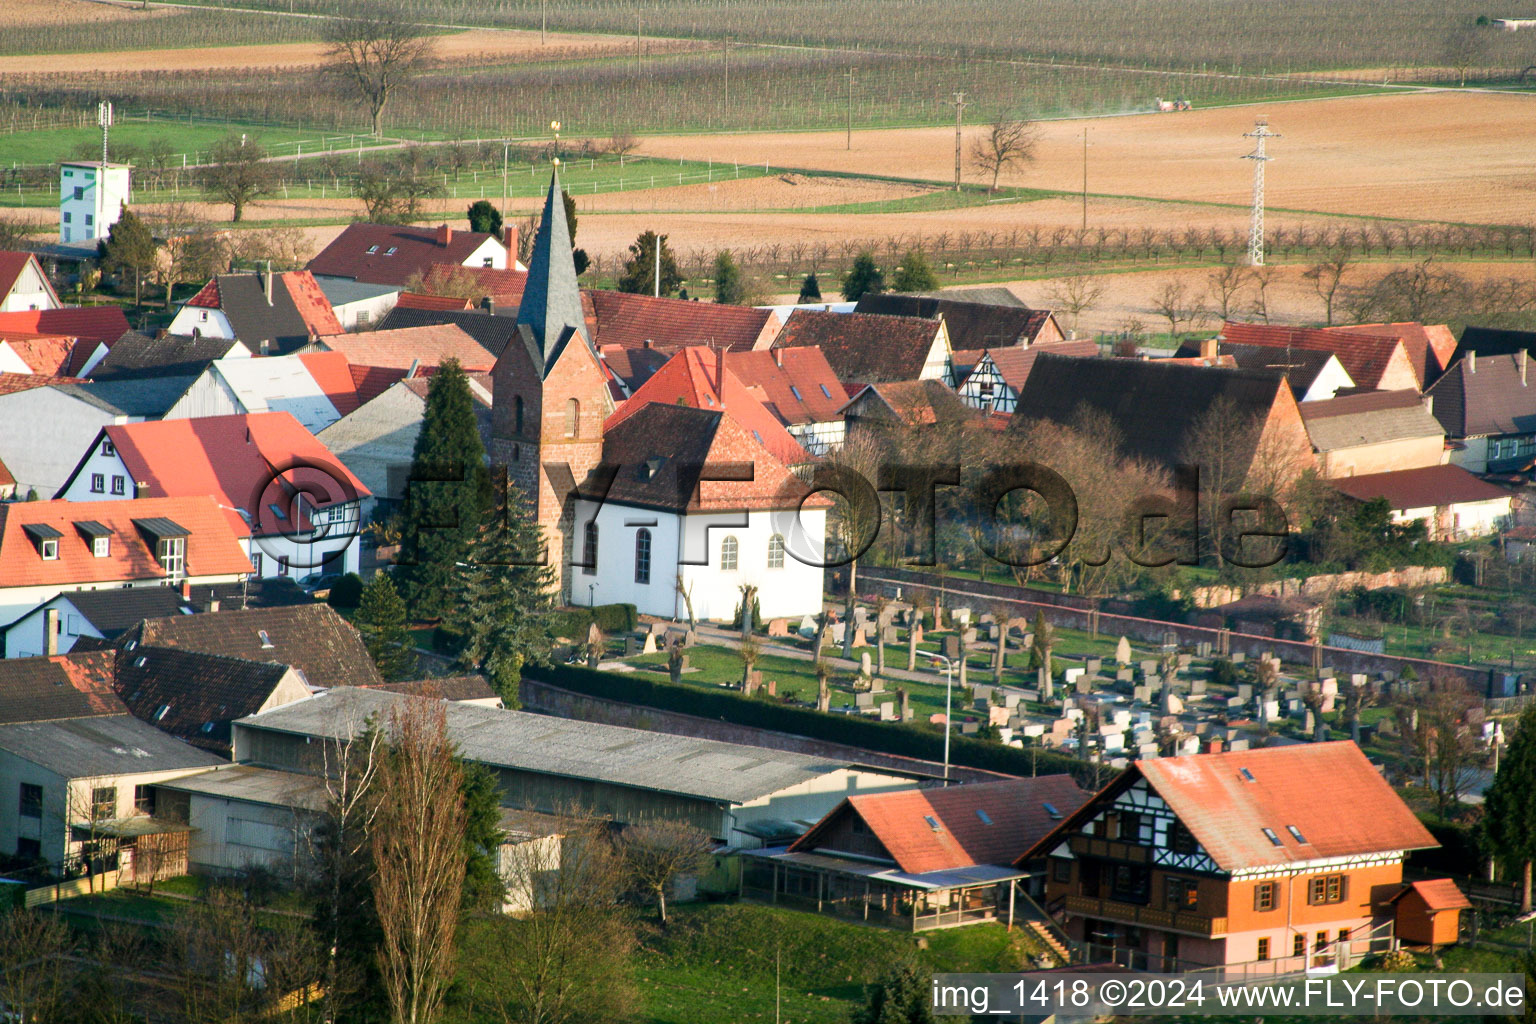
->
<box><xmin>790</xmin><ymin>775</ymin><xmax>1089</xmax><ymax>875</ymax></box>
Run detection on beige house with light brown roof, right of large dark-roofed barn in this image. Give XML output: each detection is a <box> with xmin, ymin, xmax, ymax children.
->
<box><xmin>1301</xmin><ymin>391</ymin><xmax>1445</xmax><ymax>477</ymax></box>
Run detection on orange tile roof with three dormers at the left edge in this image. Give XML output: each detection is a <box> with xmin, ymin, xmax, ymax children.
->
<box><xmin>0</xmin><ymin>494</ymin><xmax>251</xmax><ymax>586</ymax></box>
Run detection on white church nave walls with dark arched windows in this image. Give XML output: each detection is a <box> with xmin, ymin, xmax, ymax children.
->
<box><xmin>568</xmin><ymin>500</ymin><xmax>826</xmax><ymax>622</ymax></box>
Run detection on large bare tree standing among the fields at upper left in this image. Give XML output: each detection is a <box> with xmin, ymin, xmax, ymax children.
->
<box><xmin>324</xmin><ymin>0</ymin><xmax>433</xmax><ymax>135</ymax></box>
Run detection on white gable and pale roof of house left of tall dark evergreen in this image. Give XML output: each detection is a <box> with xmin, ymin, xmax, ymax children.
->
<box><xmin>164</xmin><ymin>356</ymin><xmax>350</xmax><ymax>433</ymax></box>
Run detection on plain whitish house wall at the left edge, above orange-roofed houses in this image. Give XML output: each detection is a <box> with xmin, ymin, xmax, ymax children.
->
<box><xmin>0</xmin><ymin>387</ymin><xmax>143</xmax><ymax>499</ymax></box>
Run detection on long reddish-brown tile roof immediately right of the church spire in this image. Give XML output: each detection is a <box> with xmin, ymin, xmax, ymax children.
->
<box><xmin>582</xmin><ymin>289</ymin><xmax>779</xmax><ymax>352</ymax></box>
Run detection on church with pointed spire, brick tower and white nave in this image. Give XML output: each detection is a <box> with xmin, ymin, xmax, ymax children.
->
<box><xmin>490</xmin><ymin>167</ymin><xmax>831</xmax><ymax>620</ymax></box>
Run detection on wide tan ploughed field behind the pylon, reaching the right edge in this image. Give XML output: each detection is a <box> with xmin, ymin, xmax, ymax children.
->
<box><xmin>629</xmin><ymin>91</ymin><xmax>1536</xmax><ymax>223</ymax></box>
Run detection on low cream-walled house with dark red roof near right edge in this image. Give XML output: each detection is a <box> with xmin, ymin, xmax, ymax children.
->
<box><xmin>1333</xmin><ymin>465</ymin><xmax>1514</xmax><ymax>540</ymax></box>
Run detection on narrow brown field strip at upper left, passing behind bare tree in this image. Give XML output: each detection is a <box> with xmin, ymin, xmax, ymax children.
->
<box><xmin>0</xmin><ymin>26</ymin><xmax>634</xmax><ymax>74</ymax></box>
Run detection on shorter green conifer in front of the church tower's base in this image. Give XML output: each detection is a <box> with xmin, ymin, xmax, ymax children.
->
<box><xmin>450</xmin><ymin>487</ymin><xmax>554</xmax><ymax>708</ymax></box>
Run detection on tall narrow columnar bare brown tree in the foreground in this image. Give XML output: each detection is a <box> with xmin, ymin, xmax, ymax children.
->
<box><xmin>370</xmin><ymin>697</ymin><xmax>465</xmax><ymax>1024</ymax></box>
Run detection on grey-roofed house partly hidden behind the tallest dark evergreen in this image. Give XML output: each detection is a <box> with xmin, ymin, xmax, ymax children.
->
<box><xmin>316</xmin><ymin>375</ymin><xmax>492</xmax><ymax>516</ymax></box>
